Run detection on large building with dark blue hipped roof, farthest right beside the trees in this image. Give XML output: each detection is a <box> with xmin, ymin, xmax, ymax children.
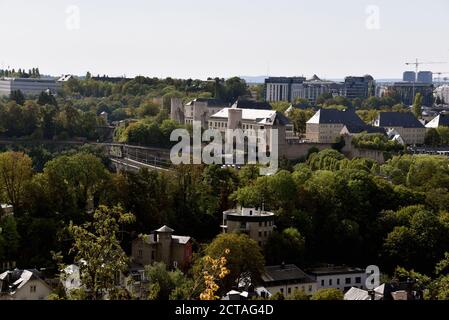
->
<box><xmin>374</xmin><ymin>112</ymin><xmax>426</xmax><ymax>145</ymax></box>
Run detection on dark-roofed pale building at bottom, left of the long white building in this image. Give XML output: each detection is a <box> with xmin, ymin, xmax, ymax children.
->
<box><xmin>261</xmin><ymin>264</ymin><xmax>318</xmax><ymax>296</ymax></box>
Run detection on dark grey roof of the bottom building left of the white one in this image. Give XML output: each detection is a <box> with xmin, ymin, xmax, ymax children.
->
<box><xmin>261</xmin><ymin>264</ymin><xmax>315</xmax><ymax>285</ymax></box>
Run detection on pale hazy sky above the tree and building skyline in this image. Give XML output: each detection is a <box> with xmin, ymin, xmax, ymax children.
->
<box><xmin>0</xmin><ymin>0</ymin><xmax>449</xmax><ymax>78</ymax></box>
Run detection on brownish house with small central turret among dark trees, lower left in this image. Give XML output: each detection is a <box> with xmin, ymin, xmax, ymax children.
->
<box><xmin>131</xmin><ymin>226</ymin><xmax>192</xmax><ymax>269</ymax></box>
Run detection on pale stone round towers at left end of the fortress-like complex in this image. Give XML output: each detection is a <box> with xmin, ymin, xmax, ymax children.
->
<box><xmin>170</xmin><ymin>98</ymin><xmax>229</xmax><ymax>128</ymax></box>
